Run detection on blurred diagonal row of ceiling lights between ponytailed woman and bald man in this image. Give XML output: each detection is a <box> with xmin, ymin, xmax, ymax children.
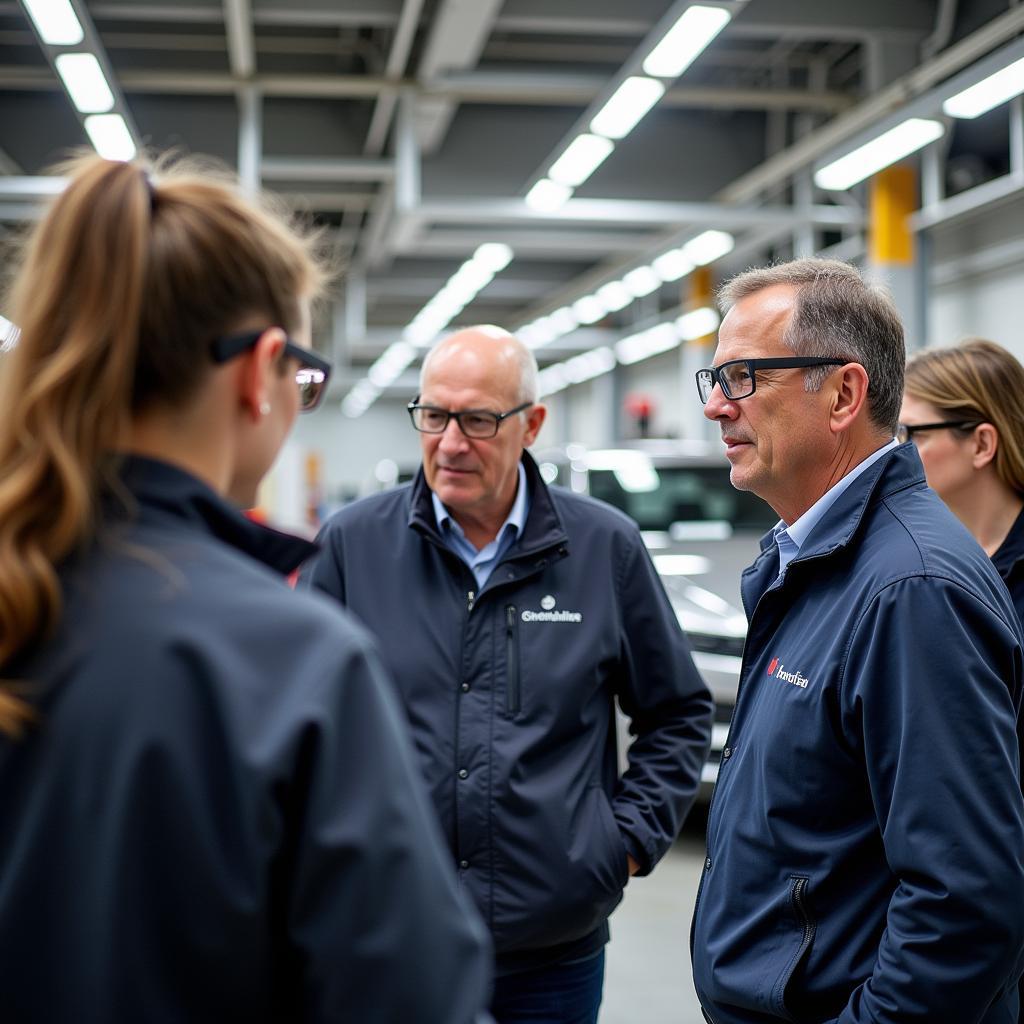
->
<box><xmin>341</xmin><ymin>242</ymin><xmax>514</xmax><ymax>419</ymax></box>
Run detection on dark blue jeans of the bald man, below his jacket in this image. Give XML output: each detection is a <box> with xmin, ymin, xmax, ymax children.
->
<box><xmin>490</xmin><ymin>949</ymin><xmax>604</xmax><ymax>1024</ymax></box>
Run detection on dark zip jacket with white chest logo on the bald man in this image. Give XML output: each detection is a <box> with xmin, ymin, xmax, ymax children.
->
<box><xmin>304</xmin><ymin>455</ymin><xmax>712</xmax><ymax>974</ymax></box>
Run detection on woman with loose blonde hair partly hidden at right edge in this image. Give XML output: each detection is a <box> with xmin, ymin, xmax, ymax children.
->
<box><xmin>899</xmin><ymin>338</ymin><xmax>1024</xmax><ymax>621</ymax></box>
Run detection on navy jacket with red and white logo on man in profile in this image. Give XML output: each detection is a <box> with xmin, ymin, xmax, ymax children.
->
<box><xmin>692</xmin><ymin>443</ymin><xmax>1024</xmax><ymax>1024</ymax></box>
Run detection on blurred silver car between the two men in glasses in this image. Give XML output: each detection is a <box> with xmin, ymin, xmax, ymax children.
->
<box><xmin>535</xmin><ymin>440</ymin><xmax>778</xmax><ymax>800</ymax></box>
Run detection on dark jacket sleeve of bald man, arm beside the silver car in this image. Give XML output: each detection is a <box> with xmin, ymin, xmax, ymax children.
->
<box><xmin>612</xmin><ymin>536</ymin><xmax>715</xmax><ymax>874</ymax></box>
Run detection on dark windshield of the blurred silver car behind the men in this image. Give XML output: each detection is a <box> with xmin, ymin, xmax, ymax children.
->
<box><xmin>590</xmin><ymin>466</ymin><xmax>778</xmax><ymax>532</ymax></box>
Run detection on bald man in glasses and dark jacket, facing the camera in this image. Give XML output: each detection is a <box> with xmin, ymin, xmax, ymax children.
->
<box><xmin>307</xmin><ymin>328</ymin><xmax>713</xmax><ymax>1024</ymax></box>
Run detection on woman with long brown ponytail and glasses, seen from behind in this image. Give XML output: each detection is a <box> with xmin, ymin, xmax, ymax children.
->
<box><xmin>0</xmin><ymin>157</ymin><xmax>486</xmax><ymax>1024</ymax></box>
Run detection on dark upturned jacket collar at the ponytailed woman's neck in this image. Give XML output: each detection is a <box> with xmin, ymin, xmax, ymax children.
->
<box><xmin>104</xmin><ymin>455</ymin><xmax>317</xmax><ymax>574</ymax></box>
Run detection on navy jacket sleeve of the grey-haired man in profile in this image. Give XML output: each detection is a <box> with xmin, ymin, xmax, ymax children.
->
<box><xmin>839</xmin><ymin>578</ymin><xmax>1024</xmax><ymax>1024</ymax></box>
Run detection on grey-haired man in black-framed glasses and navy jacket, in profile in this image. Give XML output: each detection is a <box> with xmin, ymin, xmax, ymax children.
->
<box><xmin>691</xmin><ymin>259</ymin><xmax>1024</xmax><ymax>1024</ymax></box>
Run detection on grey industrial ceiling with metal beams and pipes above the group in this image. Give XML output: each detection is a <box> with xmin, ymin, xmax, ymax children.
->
<box><xmin>0</xmin><ymin>0</ymin><xmax>1024</xmax><ymax>411</ymax></box>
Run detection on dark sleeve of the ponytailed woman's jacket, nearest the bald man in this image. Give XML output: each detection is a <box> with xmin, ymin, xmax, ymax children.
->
<box><xmin>275</xmin><ymin>626</ymin><xmax>490</xmax><ymax>1024</ymax></box>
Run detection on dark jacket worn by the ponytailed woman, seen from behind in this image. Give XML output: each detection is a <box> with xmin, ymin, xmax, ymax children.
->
<box><xmin>0</xmin><ymin>459</ymin><xmax>489</xmax><ymax>1024</ymax></box>
